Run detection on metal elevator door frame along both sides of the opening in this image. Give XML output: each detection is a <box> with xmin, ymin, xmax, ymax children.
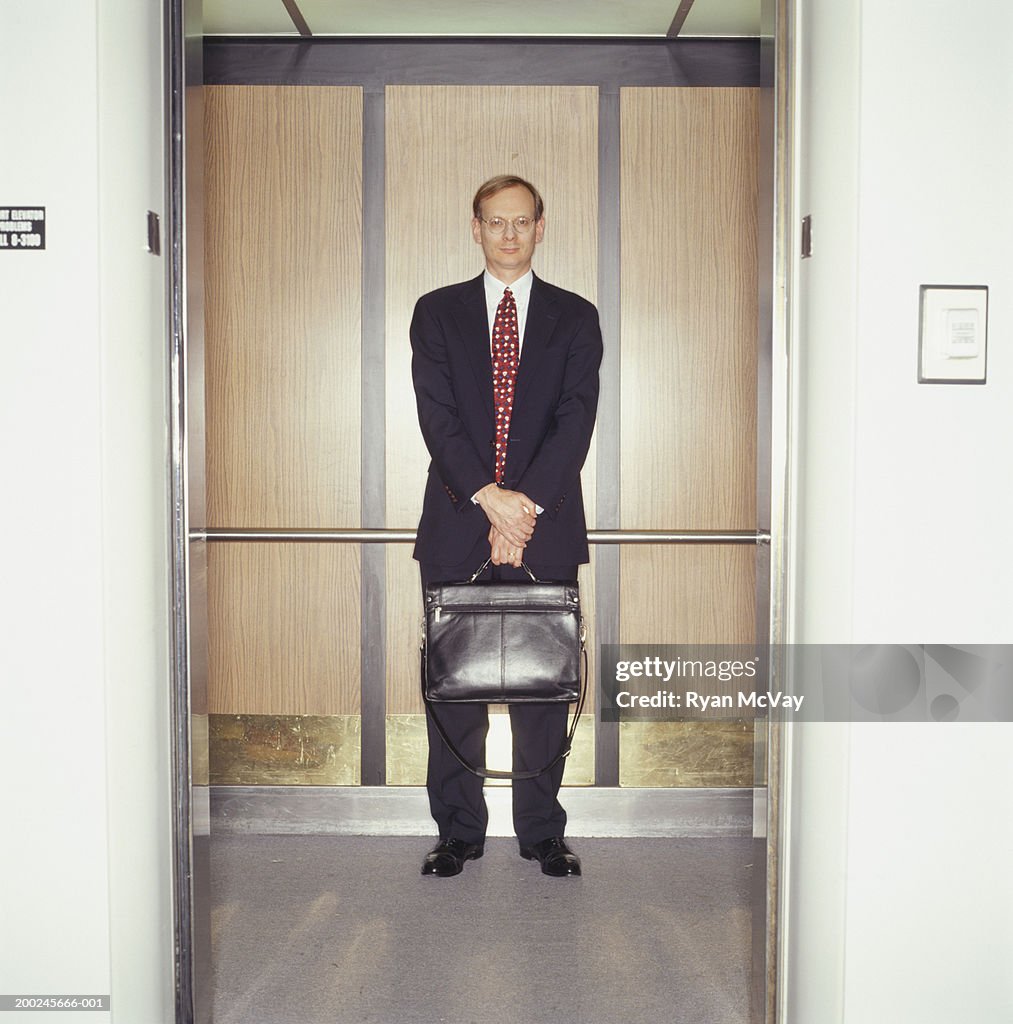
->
<box><xmin>167</xmin><ymin>9</ymin><xmax>788</xmax><ymax>1021</ymax></box>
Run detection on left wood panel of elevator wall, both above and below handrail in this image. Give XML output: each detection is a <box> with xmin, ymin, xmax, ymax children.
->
<box><xmin>205</xmin><ymin>86</ymin><xmax>363</xmax><ymax>715</ymax></box>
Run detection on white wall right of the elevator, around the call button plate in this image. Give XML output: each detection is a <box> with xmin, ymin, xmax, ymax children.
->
<box><xmin>782</xmin><ymin>0</ymin><xmax>1013</xmax><ymax>1024</ymax></box>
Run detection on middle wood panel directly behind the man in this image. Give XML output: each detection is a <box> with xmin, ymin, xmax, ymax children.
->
<box><xmin>386</xmin><ymin>86</ymin><xmax>607</xmax><ymax>714</ymax></box>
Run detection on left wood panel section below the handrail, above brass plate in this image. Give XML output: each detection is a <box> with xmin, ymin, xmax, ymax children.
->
<box><xmin>208</xmin><ymin>543</ymin><xmax>360</xmax><ymax>715</ymax></box>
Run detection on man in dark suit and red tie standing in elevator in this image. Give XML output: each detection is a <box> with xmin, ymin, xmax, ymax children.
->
<box><xmin>411</xmin><ymin>175</ymin><xmax>601</xmax><ymax>877</ymax></box>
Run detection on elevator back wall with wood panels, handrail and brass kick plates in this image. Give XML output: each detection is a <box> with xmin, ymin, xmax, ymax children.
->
<box><xmin>165</xmin><ymin>16</ymin><xmax>775</xmax><ymax>1021</ymax></box>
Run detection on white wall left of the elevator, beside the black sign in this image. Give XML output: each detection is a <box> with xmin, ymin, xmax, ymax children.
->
<box><xmin>0</xmin><ymin>0</ymin><xmax>173</xmax><ymax>1024</ymax></box>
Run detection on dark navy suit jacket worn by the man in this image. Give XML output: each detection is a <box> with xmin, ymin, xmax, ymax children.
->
<box><xmin>411</xmin><ymin>274</ymin><xmax>601</xmax><ymax>568</ymax></box>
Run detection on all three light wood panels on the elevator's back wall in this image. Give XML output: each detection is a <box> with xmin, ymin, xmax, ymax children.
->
<box><xmin>205</xmin><ymin>86</ymin><xmax>757</xmax><ymax>753</ymax></box>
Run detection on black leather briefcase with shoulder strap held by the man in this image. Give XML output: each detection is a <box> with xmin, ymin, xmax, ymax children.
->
<box><xmin>421</xmin><ymin>561</ymin><xmax>587</xmax><ymax>778</ymax></box>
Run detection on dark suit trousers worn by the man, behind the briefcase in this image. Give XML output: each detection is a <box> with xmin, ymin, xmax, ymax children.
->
<box><xmin>420</xmin><ymin>548</ymin><xmax>577</xmax><ymax>846</ymax></box>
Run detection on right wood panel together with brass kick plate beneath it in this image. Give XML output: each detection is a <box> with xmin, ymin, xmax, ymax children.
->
<box><xmin>620</xmin><ymin>89</ymin><xmax>758</xmax><ymax>785</ymax></box>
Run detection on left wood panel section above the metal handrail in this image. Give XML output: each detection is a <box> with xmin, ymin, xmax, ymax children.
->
<box><xmin>205</xmin><ymin>86</ymin><xmax>363</xmax><ymax>526</ymax></box>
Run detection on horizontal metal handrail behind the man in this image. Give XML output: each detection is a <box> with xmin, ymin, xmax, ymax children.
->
<box><xmin>189</xmin><ymin>526</ymin><xmax>770</xmax><ymax>544</ymax></box>
